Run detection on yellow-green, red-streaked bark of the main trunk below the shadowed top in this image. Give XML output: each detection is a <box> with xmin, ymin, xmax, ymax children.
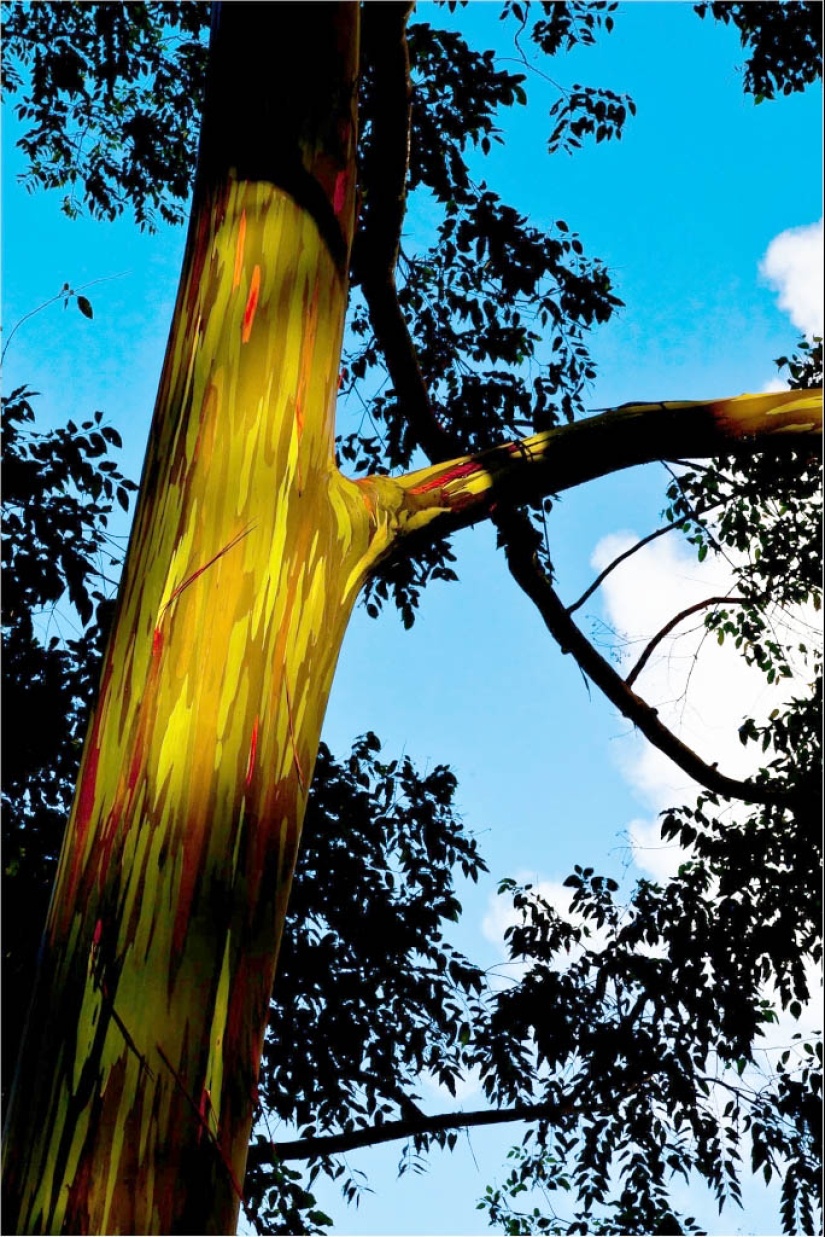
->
<box><xmin>5</xmin><ymin>5</ymin><xmax>368</xmax><ymax>1233</ymax></box>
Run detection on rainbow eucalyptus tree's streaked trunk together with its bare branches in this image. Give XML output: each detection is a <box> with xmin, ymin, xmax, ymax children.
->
<box><xmin>4</xmin><ymin>2</ymin><xmax>821</xmax><ymax>1233</ymax></box>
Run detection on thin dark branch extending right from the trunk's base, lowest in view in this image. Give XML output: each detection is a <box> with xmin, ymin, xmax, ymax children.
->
<box><xmin>247</xmin><ymin>1103</ymin><xmax>573</xmax><ymax>1168</ymax></box>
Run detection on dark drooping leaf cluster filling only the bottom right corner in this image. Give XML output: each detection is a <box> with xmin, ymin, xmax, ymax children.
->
<box><xmin>479</xmin><ymin>809</ymin><xmax>821</xmax><ymax>1233</ymax></box>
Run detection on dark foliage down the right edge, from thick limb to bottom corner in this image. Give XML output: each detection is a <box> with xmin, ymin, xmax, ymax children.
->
<box><xmin>480</xmin><ymin>341</ymin><xmax>823</xmax><ymax>1233</ymax></box>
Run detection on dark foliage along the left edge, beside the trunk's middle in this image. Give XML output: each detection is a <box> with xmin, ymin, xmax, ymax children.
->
<box><xmin>2</xmin><ymin>387</ymin><xmax>136</xmax><ymax>1086</ymax></box>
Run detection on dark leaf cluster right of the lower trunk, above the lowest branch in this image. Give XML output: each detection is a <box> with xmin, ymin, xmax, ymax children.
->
<box><xmin>247</xmin><ymin>734</ymin><xmax>486</xmax><ymax>1232</ymax></box>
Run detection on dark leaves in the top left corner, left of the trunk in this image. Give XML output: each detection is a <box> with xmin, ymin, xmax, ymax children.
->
<box><xmin>2</xmin><ymin>0</ymin><xmax>209</xmax><ymax>228</ymax></box>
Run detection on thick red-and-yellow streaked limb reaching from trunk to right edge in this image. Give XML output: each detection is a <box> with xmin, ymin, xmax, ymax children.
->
<box><xmin>385</xmin><ymin>391</ymin><xmax>823</xmax><ymax>536</ymax></box>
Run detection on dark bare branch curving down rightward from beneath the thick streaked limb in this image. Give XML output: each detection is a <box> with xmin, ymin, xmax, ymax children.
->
<box><xmin>497</xmin><ymin>512</ymin><xmax>795</xmax><ymax>807</ymax></box>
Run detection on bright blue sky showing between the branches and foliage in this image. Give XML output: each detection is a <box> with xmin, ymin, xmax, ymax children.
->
<box><xmin>2</xmin><ymin>0</ymin><xmax>821</xmax><ymax>1235</ymax></box>
